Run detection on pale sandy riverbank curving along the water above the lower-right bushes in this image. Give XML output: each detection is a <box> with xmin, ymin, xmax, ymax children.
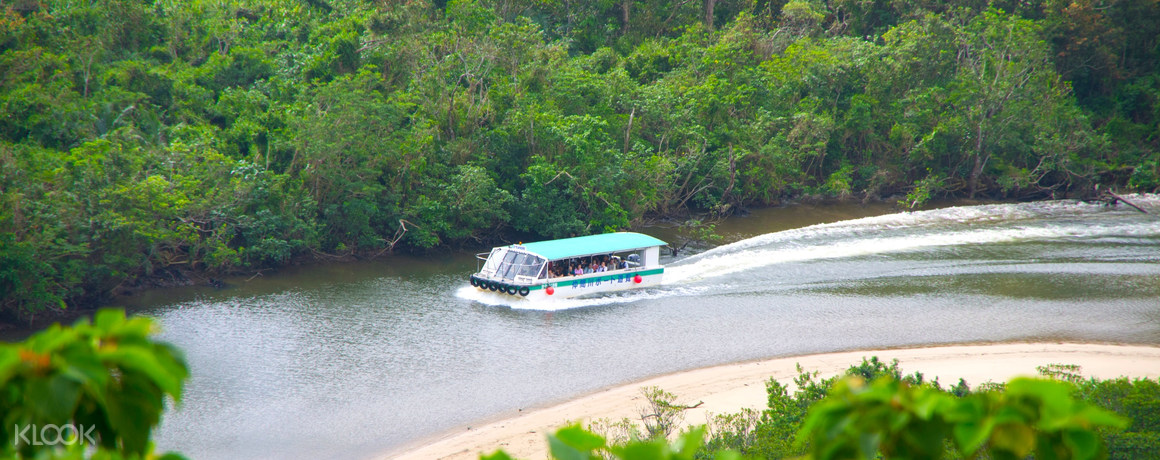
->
<box><xmin>385</xmin><ymin>343</ymin><xmax>1160</xmax><ymax>460</ymax></box>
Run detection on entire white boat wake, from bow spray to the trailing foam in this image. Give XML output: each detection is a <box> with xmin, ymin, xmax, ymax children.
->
<box><xmin>456</xmin><ymin>195</ymin><xmax>1160</xmax><ymax>311</ymax></box>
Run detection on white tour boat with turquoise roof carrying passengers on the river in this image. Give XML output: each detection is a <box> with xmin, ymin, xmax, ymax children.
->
<box><xmin>470</xmin><ymin>232</ymin><xmax>666</xmax><ymax>299</ymax></box>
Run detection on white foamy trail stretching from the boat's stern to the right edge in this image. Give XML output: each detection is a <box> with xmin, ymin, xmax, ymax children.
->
<box><xmin>665</xmin><ymin>195</ymin><xmax>1160</xmax><ymax>284</ymax></box>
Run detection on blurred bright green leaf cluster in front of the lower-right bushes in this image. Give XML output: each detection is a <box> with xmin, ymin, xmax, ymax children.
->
<box><xmin>798</xmin><ymin>377</ymin><xmax>1128</xmax><ymax>459</ymax></box>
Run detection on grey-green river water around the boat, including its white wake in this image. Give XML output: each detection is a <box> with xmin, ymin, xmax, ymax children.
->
<box><xmin>120</xmin><ymin>196</ymin><xmax>1160</xmax><ymax>460</ymax></box>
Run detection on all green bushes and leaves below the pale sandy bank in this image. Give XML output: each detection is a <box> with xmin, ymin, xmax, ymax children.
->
<box><xmin>481</xmin><ymin>358</ymin><xmax>1160</xmax><ymax>460</ymax></box>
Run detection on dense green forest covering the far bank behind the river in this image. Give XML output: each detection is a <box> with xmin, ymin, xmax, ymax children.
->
<box><xmin>0</xmin><ymin>0</ymin><xmax>1160</xmax><ymax>320</ymax></box>
